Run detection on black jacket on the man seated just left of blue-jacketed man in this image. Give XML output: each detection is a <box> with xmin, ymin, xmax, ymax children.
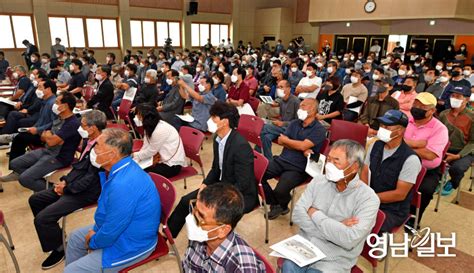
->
<box><xmin>61</xmin><ymin>139</ymin><xmax>101</xmax><ymax>201</ymax></box>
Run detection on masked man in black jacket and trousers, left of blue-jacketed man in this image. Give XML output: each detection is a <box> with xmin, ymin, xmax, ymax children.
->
<box><xmin>29</xmin><ymin>110</ymin><xmax>107</xmax><ymax>270</ymax></box>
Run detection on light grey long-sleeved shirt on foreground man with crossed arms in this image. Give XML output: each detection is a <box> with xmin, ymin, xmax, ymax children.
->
<box><xmin>293</xmin><ymin>175</ymin><xmax>380</xmax><ymax>273</ymax></box>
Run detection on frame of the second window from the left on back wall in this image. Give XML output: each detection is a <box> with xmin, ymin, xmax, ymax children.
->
<box><xmin>47</xmin><ymin>13</ymin><xmax>122</xmax><ymax>50</ymax></box>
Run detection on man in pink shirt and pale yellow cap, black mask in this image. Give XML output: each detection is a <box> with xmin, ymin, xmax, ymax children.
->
<box><xmin>404</xmin><ymin>92</ymin><xmax>449</xmax><ymax>227</ymax></box>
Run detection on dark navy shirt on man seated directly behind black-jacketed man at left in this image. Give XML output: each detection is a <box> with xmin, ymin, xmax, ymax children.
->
<box><xmin>56</xmin><ymin>115</ymin><xmax>81</xmax><ymax>166</ymax></box>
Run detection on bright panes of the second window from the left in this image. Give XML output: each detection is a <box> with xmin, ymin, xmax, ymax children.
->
<box><xmin>49</xmin><ymin>17</ymin><xmax>118</xmax><ymax>47</ymax></box>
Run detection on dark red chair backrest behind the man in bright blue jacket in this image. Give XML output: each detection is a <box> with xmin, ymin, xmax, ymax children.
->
<box><xmin>148</xmin><ymin>173</ymin><xmax>176</xmax><ymax>225</ymax></box>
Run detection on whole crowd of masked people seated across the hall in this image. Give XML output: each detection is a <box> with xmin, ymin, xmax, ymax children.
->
<box><xmin>0</xmin><ymin>37</ymin><xmax>474</xmax><ymax>273</ymax></box>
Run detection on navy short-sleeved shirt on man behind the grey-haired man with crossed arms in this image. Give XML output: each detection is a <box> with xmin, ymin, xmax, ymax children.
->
<box><xmin>279</xmin><ymin>119</ymin><xmax>326</xmax><ymax>171</ymax></box>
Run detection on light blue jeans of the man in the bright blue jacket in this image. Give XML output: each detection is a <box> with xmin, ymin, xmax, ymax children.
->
<box><xmin>64</xmin><ymin>225</ymin><xmax>153</xmax><ymax>273</ymax></box>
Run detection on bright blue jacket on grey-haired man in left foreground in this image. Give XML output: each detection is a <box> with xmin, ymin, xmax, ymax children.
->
<box><xmin>89</xmin><ymin>157</ymin><xmax>161</xmax><ymax>268</ymax></box>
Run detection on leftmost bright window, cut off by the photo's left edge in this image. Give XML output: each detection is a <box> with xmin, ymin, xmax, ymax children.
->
<box><xmin>0</xmin><ymin>15</ymin><xmax>36</xmax><ymax>48</ymax></box>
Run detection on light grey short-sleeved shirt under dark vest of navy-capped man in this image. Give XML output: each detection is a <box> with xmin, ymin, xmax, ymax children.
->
<box><xmin>364</xmin><ymin>142</ymin><xmax>421</xmax><ymax>184</ymax></box>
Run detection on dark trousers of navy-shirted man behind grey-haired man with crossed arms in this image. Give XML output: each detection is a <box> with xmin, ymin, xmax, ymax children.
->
<box><xmin>262</xmin><ymin>157</ymin><xmax>308</xmax><ymax>209</ymax></box>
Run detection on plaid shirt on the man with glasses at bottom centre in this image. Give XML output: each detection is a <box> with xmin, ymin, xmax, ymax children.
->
<box><xmin>183</xmin><ymin>232</ymin><xmax>265</xmax><ymax>273</ymax></box>
